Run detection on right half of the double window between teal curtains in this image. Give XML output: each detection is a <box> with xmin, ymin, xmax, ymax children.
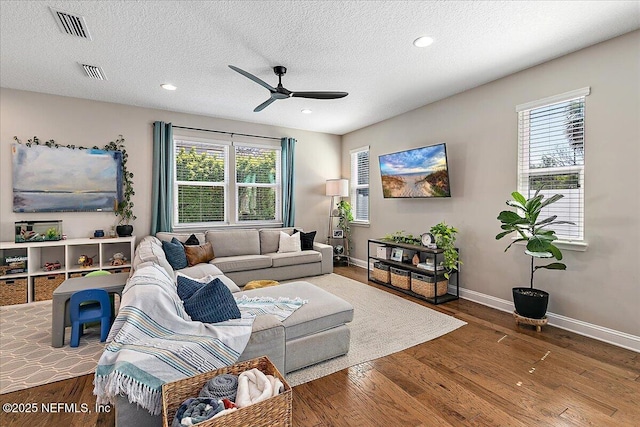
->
<box><xmin>235</xmin><ymin>145</ymin><xmax>282</xmax><ymax>222</ymax></box>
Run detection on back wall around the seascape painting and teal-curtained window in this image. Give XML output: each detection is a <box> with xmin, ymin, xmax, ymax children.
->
<box><xmin>0</xmin><ymin>88</ymin><xmax>340</xmax><ymax>241</ymax></box>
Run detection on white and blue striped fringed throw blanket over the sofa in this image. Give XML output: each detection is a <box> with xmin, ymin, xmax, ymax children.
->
<box><xmin>93</xmin><ymin>263</ymin><xmax>254</xmax><ymax>415</ymax></box>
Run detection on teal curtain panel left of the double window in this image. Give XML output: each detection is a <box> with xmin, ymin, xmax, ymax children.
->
<box><xmin>151</xmin><ymin>122</ymin><xmax>173</xmax><ymax>235</ymax></box>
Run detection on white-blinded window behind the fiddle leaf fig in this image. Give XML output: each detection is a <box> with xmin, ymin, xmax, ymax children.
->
<box><xmin>516</xmin><ymin>88</ymin><xmax>589</xmax><ymax>242</ymax></box>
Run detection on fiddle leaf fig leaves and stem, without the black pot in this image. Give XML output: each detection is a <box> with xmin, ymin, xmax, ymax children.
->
<box><xmin>496</xmin><ymin>189</ymin><xmax>575</xmax><ymax>289</ymax></box>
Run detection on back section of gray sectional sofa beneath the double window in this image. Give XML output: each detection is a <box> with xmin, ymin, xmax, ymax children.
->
<box><xmin>156</xmin><ymin>228</ymin><xmax>333</xmax><ymax>287</ymax></box>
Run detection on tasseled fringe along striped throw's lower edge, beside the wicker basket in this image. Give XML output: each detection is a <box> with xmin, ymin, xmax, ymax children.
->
<box><xmin>93</xmin><ymin>371</ymin><xmax>162</xmax><ymax>415</ymax></box>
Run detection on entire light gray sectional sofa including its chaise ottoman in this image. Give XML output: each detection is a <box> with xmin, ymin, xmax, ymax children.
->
<box><xmin>115</xmin><ymin>229</ymin><xmax>353</xmax><ymax>427</ymax></box>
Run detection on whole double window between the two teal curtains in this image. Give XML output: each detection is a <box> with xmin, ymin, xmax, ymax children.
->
<box><xmin>174</xmin><ymin>137</ymin><xmax>282</xmax><ymax>228</ymax></box>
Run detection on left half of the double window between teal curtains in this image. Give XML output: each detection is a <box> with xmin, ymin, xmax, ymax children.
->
<box><xmin>174</xmin><ymin>139</ymin><xmax>228</xmax><ymax>225</ymax></box>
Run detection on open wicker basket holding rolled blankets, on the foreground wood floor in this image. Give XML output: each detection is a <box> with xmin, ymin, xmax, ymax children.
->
<box><xmin>162</xmin><ymin>356</ymin><xmax>292</xmax><ymax>427</ymax></box>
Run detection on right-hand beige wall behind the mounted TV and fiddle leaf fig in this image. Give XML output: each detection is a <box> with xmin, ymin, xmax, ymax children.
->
<box><xmin>342</xmin><ymin>31</ymin><xmax>640</xmax><ymax>336</ymax></box>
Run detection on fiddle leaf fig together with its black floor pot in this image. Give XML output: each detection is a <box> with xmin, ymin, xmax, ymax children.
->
<box><xmin>496</xmin><ymin>189</ymin><xmax>575</xmax><ymax>319</ymax></box>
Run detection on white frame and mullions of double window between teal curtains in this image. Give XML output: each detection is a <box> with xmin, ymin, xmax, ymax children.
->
<box><xmin>171</xmin><ymin>134</ymin><xmax>282</xmax><ymax>230</ymax></box>
